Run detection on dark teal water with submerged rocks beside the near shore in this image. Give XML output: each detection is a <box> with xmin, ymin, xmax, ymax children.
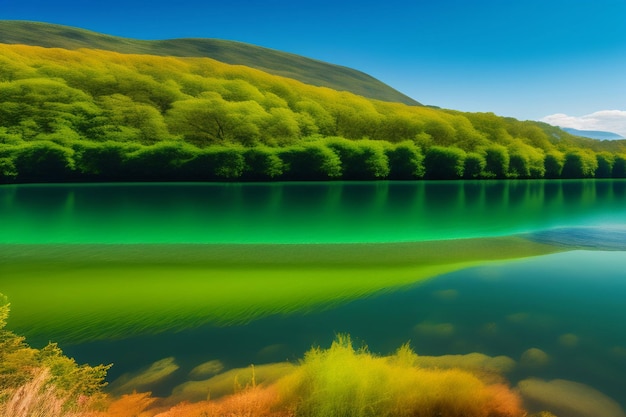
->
<box><xmin>50</xmin><ymin>251</ymin><xmax>626</xmax><ymax>412</ymax></box>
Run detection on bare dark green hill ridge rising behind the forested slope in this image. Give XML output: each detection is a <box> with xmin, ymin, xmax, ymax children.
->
<box><xmin>0</xmin><ymin>20</ymin><xmax>420</xmax><ymax>105</ymax></box>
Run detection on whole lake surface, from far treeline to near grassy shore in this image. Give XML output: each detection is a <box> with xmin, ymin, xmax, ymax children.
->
<box><xmin>0</xmin><ymin>180</ymin><xmax>626</xmax><ymax>414</ymax></box>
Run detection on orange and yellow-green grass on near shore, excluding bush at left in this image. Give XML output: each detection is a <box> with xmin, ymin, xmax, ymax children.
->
<box><xmin>91</xmin><ymin>336</ymin><xmax>526</xmax><ymax>417</ymax></box>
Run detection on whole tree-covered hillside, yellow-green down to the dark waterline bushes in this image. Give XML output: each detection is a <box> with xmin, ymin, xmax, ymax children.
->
<box><xmin>0</xmin><ymin>41</ymin><xmax>626</xmax><ymax>183</ymax></box>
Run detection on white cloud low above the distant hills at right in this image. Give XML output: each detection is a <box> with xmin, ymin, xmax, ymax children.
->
<box><xmin>541</xmin><ymin>110</ymin><xmax>626</xmax><ymax>137</ymax></box>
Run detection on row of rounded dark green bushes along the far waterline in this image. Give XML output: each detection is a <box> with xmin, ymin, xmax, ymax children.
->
<box><xmin>0</xmin><ymin>137</ymin><xmax>626</xmax><ymax>183</ymax></box>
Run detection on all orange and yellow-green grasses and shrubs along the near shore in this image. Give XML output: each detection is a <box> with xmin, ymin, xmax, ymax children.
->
<box><xmin>0</xmin><ymin>292</ymin><xmax>560</xmax><ymax>417</ymax></box>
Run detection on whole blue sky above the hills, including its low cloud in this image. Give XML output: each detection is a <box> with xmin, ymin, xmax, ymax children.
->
<box><xmin>0</xmin><ymin>0</ymin><xmax>626</xmax><ymax>136</ymax></box>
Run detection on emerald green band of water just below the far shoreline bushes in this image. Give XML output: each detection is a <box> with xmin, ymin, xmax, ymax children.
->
<box><xmin>0</xmin><ymin>180</ymin><xmax>626</xmax><ymax>244</ymax></box>
